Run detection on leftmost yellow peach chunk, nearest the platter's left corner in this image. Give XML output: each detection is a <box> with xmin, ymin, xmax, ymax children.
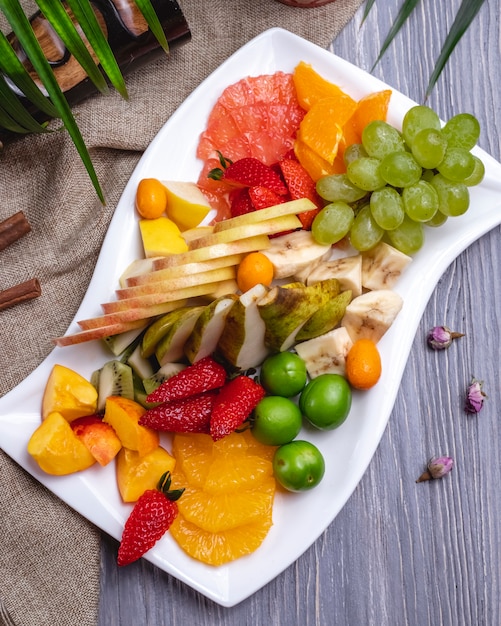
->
<box><xmin>28</xmin><ymin>412</ymin><xmax>96</xmax><ymax>476</ymax></box>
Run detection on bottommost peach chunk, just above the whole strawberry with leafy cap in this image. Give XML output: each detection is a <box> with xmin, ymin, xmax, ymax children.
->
<box><xmin>116</xmin><ymin>446</ymin><xmax>176</xmax><ymax>502</ymax></box>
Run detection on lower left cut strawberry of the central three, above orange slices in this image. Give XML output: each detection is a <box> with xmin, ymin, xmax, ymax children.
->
<box><xmin>139</xmin><ymin>390</ymin><xmax>217</xmax><ymax>433</ymax></box>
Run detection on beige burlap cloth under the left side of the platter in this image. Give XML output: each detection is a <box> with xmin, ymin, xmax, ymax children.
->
<box><xmin>0</xmin><ymin>0</ymin><xmax>361</xmax><ymax>626</ymax></box>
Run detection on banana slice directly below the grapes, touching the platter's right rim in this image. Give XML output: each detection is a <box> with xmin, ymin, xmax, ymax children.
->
<box><xmin>361</xmin><ymin>241</ymin><xmax>412</xmax><ymax>290</ymax></box>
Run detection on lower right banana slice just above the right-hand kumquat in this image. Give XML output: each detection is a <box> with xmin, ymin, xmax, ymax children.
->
<box><xmin>341</xmin><ymin>289</ymin><xmax>403</xmax><ymax>343</ymax></box>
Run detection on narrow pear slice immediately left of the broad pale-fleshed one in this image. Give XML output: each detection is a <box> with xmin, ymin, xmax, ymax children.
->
<box><xmin>184</xmin><ymin>294</ymin><xmax>238</xmax><ymax>363</ymax></box>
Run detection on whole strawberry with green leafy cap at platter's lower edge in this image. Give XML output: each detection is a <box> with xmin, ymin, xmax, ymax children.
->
<box><xmin>117</xmin><ymin>472</ymin><xmax>184</xmax><ymax>565</ymax></box>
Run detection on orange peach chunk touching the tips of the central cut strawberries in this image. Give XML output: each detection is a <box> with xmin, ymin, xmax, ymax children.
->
<box><xmin>103</xmin><ymin>396</ymin><xmax>160</xmax><ymax>456</ymax></box>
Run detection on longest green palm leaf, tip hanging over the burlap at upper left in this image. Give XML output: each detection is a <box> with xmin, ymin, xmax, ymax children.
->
<box><xmin>0</xmin><ymin>0</ymin><xmax>104</xmax><ymax>204</ymax></box>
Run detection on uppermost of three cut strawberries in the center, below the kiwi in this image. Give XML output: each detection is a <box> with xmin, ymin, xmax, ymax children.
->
<box><xmin>146</xmin><ymin>356</ymin><xmax>226</xmax><ymax>403</ymax></box>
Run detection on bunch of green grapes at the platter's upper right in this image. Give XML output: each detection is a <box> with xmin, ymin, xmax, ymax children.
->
<box><xmin>312</xmin><ymin>105</ymin><xmax>485</xmax><ymax>255</ymax></box>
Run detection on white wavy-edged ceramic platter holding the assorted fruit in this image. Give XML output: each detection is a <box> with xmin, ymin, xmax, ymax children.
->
<box><xmin>0</xmin><ymin>28</ymin><xmax>501</xmax><ymax>606</ymax></box>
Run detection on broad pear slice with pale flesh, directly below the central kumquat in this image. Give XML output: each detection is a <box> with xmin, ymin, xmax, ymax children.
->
<box><xmin>217</xmin><ymin>284</ymin><xmax>270</xmax><ymax>371</ymax></box>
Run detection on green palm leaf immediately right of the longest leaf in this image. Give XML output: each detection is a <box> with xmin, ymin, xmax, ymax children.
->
<box><xmin>37</xmin><ymin>0</ymin><xmax>108</xmax><ymax>93</ymax></box>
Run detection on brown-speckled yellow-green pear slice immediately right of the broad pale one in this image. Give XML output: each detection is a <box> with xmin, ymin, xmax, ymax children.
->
<box><xmin>258</xmin><ymin>285</ymin><xmax>329</xmax><ymax>352</ymax></box>
